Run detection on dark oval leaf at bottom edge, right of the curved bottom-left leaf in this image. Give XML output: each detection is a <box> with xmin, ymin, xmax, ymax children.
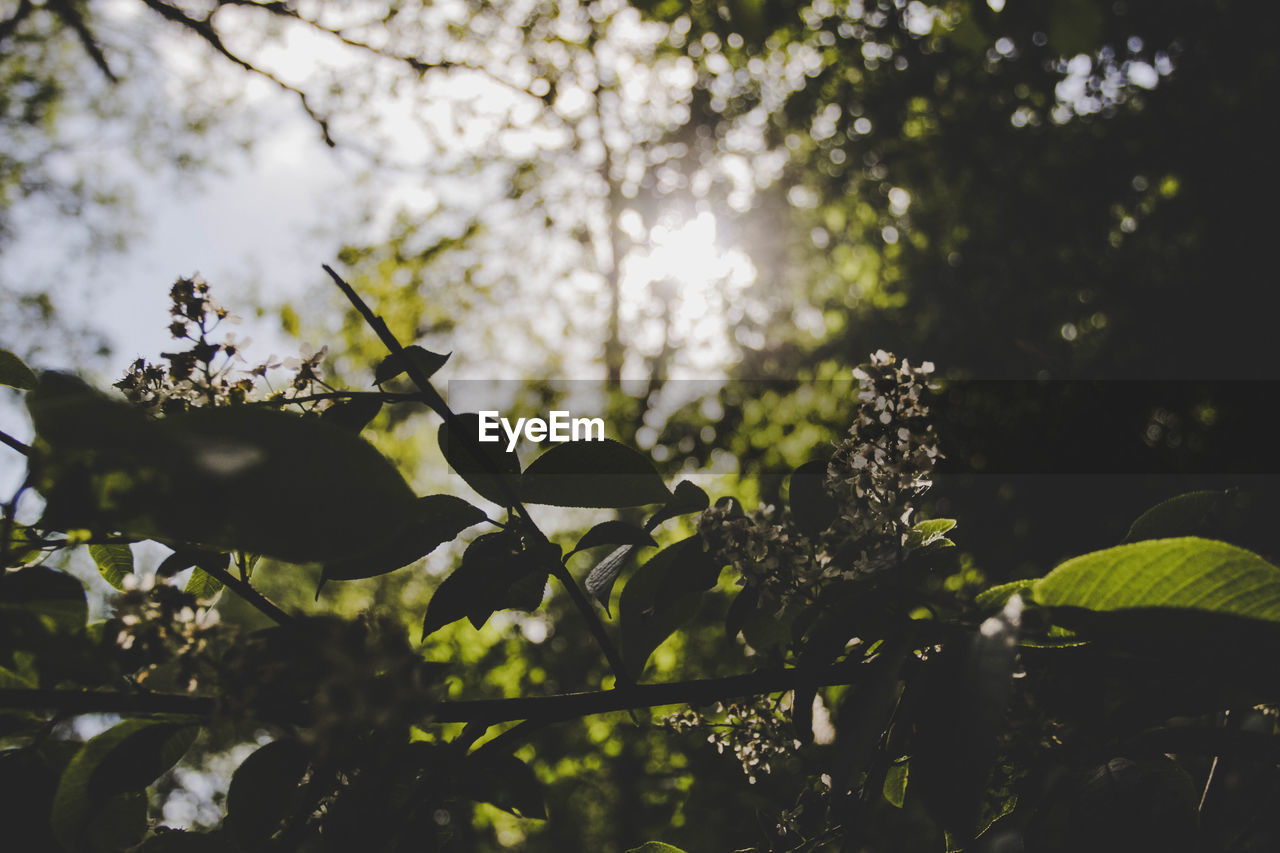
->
<box><xmin>227</xmin><ymin>739</ymin><xmax>311</xmax><ymax>850</ymax></box>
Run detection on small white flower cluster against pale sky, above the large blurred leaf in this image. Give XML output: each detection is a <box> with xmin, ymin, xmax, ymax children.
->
<box><xmin>115</xmin><ymin>275</ymin><xmax>326</xmax><ymax>414</ymax></box>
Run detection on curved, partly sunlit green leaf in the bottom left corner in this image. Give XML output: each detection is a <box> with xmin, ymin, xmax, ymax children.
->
<box><xmin>51</xmin><ymin>720</ymin><xmax>198</xmax><ymax>850</ymax></box>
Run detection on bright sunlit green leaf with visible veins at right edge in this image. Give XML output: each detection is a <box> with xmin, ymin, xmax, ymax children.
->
<box><xmin>1032</xmin><ymin>537</ymin><xmax>1280</xmax><ymax>622</ymax></box>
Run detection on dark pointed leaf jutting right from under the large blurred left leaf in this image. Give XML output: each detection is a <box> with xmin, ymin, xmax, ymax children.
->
<box><xmin>324</xmin><ymin>494</ymin><xmax>488</xmax><ymax>580</ymax></box>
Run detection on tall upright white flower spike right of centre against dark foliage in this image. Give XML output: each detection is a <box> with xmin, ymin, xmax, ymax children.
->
<box><xmin>826</xmin><ymin>350</ymin><xmax>942</xmax><ymax>578</ymax></box>
